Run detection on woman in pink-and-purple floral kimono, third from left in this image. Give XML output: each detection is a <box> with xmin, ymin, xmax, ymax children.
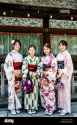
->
<box><xmin>40</xmin><ymin>43</ymin><xmax>57</xmax><ymax>115</ymax></box>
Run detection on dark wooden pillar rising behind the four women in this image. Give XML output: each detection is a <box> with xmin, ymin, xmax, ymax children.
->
<box><xmin>43</xmin><ymin>15</ymin><xmax>50</xmax><ymax>44</ymax></box>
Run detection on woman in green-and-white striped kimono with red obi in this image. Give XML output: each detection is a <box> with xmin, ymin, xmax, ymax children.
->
<box><xmin>22</xmin><ymin>45</ymin><xmax>39</xmax><ymax>114</ymax></box>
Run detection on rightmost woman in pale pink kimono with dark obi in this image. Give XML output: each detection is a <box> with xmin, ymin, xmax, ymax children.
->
<box><xmin>57</xmin><ymin>40</ymin><xmax>73</xmax><ymax>115</ymax></box>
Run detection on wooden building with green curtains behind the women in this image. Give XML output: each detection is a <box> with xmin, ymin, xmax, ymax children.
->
<box><xmin>0</xmin><ymin>0</ymin><xmax>77</xmax><ymax>107</ymax></box>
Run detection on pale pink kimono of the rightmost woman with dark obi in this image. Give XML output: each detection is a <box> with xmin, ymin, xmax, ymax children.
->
<box><xmin>57</xmin><ymin>50</ymin><xmax>73</xmax><ymax>113</ymax></box>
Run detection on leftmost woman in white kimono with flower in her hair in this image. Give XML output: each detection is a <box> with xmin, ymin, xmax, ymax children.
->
<box><xmin>4</xmin><ymin>40</ymin><xmax>23</xmax><ymax>114</ymax></box>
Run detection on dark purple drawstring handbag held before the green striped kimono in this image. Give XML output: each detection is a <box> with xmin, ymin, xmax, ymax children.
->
<box><xmin>23</xmin><ymin>72</ymin><xmax>34</xmax><ymax>94</ymax></box>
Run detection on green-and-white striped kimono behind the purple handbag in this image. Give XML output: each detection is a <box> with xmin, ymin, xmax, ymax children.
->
<box><xmin>22</xmin><ymin>55</ymin><xmax>39</xmax><ymax>111</ymax></box>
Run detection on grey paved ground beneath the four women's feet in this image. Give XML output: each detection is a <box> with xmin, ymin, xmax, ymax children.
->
<box><xmin>0</xmin><ymin>102</ymin><xmax>77</xmax><ymax>117</ymax></box>
